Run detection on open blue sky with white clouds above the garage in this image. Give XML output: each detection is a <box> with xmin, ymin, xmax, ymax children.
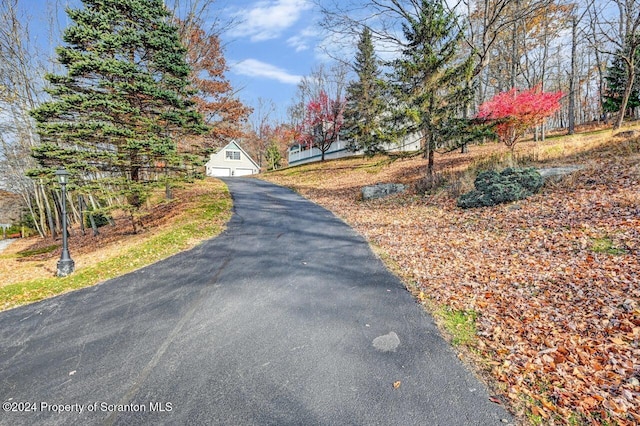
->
<box><xmin>23</xmin><ymin>0</ymin><xmax>336</xmax><ymax>121</ymax></box>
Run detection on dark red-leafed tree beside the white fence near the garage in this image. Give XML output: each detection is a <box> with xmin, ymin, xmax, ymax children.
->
<box><xmin>297</xmin><ymin>90</ymin><xmax>345</xmax><ymax>161</ymax></box>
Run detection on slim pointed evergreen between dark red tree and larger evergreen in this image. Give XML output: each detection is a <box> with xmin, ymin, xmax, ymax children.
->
<box><xmin>342</xmin><ymin>27</ymin><xmax>385</xmax><ymax>155</ymax></box>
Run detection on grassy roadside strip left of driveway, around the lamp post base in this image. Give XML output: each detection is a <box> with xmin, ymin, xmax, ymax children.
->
<box><xmin>0</xmin><ymin>179</ymin><xmax>231</xmax><ymax>310</ymax></box>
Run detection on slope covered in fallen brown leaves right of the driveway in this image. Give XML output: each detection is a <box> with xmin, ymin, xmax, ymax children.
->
<box><xmin>263</xmin><ymin>125</ymin><xmax>640</xmax><ymax>425</ymax></box>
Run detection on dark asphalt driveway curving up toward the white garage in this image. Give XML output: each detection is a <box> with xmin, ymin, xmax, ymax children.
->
<box><xmin>0</xmin><ymin>179</ymin><xmax>512</xmax><ymax>426</ymax></box>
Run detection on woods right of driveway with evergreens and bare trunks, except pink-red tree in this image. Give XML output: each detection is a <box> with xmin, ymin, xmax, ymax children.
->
<box><xmin>293</xmin><ymin>0</ymin><xmax>640</xmax><ymax>163</ymax></box>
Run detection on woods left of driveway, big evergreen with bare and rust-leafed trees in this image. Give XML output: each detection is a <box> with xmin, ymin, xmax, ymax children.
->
<box><xmin>0</xmin><ymin>0</ymin><xmax>250</xmax><ymax>239</ymax></box>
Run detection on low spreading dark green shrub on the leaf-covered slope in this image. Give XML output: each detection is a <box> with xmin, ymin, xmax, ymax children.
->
<box><xmin>458</xmin><ymin>167</ymin><xmax>543</xmax><ymax>209</ymax></box>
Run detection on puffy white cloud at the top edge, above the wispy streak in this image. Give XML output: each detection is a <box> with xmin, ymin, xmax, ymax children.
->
<box><xmin>231</xmin><ymin>0</ymin><xmax>313</xmax><ymax>41</ymax></box>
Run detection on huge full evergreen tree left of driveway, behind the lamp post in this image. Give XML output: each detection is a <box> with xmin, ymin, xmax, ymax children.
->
<box><xmin>32</xmin><ymin>0</ymin><xmax>206</xmax><ymax>228</ymax></box>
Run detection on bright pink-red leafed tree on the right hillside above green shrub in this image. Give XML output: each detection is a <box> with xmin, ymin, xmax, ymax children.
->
<box><xmin>477</xmin><ymin>85</ymin><xmax>563</xmax><ymax>151</ymax></box>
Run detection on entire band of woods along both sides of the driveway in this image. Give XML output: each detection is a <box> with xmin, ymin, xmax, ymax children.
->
<box><xmin>0</xmin><ymin>0</ymin><xmax>640</xmax><ymax>238</ymax></box>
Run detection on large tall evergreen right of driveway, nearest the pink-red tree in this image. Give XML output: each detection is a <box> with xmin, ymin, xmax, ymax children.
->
<box><xmin>391</xmin><ymin>0</ymin><xmax>473</xmax><ymax>174</ymax></box>
